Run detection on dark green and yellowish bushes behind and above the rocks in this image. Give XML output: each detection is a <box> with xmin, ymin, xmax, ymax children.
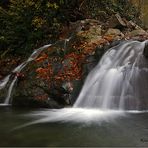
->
<box><xmin>0</xmin><ymin>0</ymin><xmax>140</xmax><ymax>58</ymax></box>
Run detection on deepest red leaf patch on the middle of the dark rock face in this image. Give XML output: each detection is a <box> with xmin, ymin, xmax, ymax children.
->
<box><xmin>36</xmin><ymin>52</ymin><xmax>84</xmax><ymax>84</ymax></box>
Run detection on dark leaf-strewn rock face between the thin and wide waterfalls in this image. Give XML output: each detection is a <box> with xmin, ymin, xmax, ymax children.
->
<box><xmin>0</xmin><ymin>16</ymin><xmax>148</xmax><ymax>108</ymax></box>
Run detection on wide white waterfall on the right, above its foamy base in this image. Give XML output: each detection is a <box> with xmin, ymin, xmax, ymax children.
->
<box><xmin>74</xmin><ymin>41</ymin><xmax>148</xmax><ymax>110</ymax></box>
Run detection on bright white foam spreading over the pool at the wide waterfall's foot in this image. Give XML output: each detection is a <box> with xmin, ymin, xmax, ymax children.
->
<box><xmin>13</xmin><ymin>108</ymin><xmax>125</xmax><ymax>130</ymax></box>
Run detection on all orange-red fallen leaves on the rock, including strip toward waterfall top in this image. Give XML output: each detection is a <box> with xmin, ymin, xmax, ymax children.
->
<box><xmin>35</xmin><ymin>29</ymin><xmax>113</xmax><ymax>86</ymax></box>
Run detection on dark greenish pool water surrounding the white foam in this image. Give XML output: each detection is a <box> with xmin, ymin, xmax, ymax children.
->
<box><xmin>0</xmin><ymin>107</ymin><xmax>148</xmax><ymax>147</ymax></box>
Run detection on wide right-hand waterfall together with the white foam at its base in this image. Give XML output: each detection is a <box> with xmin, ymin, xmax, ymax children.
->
<box><xmin>14</xmin><ymin>41</ymin><xmax>148</xmax><ymax>130</ymax></box>
